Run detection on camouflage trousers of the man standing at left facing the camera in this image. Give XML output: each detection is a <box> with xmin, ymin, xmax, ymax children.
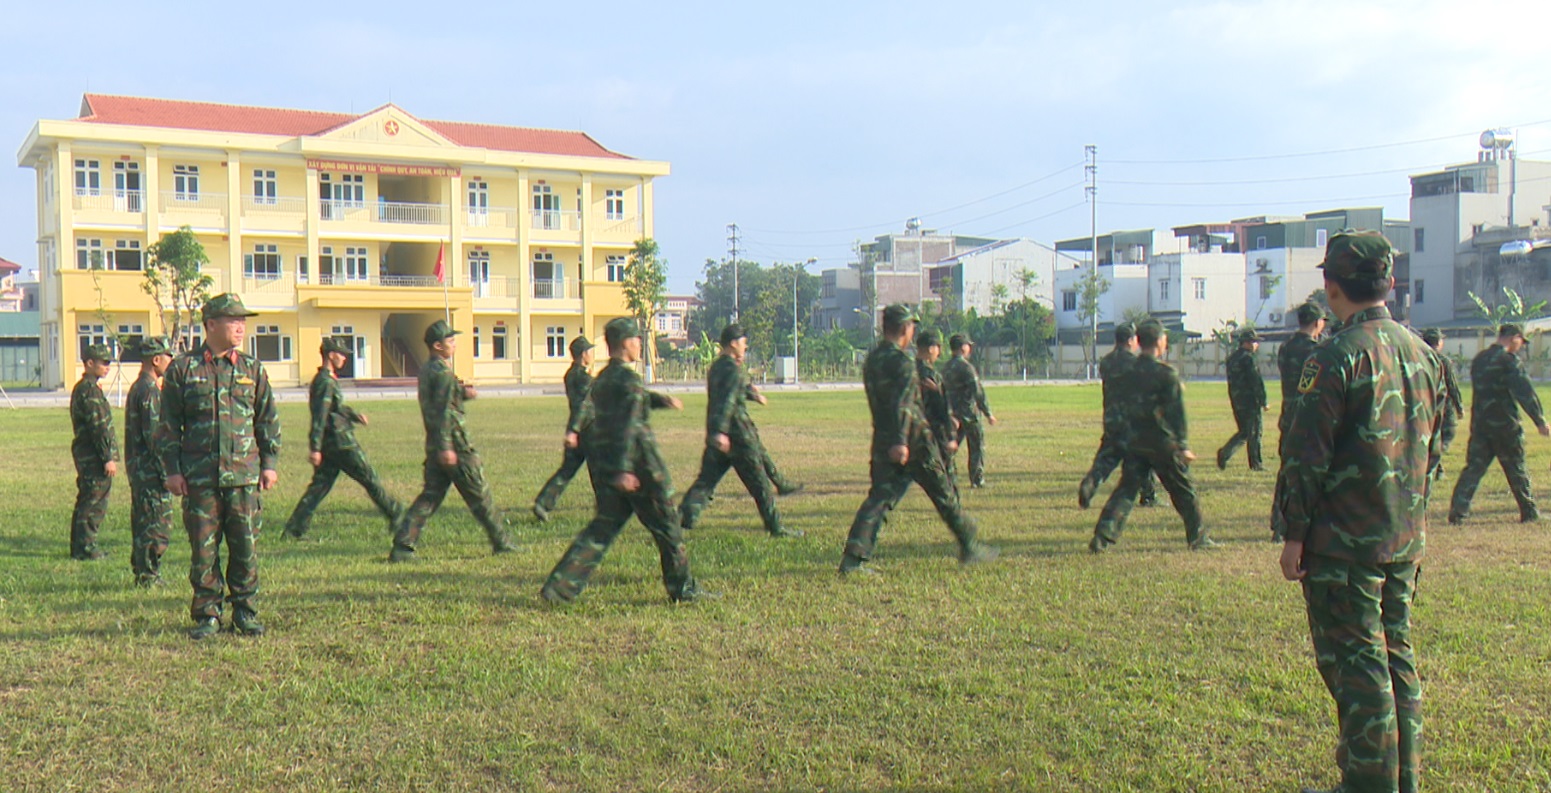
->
<box><xmin>183</xmin><ymin>484</ymin><xmax>264</xmax><ymax>621</ymax></box>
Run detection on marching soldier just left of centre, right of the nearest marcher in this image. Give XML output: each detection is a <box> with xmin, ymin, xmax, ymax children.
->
<box><xmin>679</xmin><ymin>323</ymin><xmax>802</xmax><ymax>537</ymax></box>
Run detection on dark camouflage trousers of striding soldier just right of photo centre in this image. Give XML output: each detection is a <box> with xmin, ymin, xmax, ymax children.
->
<box><xmin>845</xmin><ymin>441</ymin><xmax>976</xmax><ymax>562</ymax></box>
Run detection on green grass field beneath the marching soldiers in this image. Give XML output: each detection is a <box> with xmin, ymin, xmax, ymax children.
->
<box><xmin>0</xmin><ymin>383</ymin><xmax>1551</xmax><ymax>791</ymax></box>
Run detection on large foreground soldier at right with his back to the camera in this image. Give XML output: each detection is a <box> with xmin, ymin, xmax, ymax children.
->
<box><xmin>1278</xmin><ymin>231</ymin><xmax>1442</xmax><ymax>793</ymax></box>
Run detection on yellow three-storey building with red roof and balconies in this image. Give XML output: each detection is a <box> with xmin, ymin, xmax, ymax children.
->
<box><xmin>17</xmin><ymin>95</ymin><xmax>668</xmax><ymax>386</ymax></box>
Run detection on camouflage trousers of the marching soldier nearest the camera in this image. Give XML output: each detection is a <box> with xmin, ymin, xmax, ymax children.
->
<box><xmin>540</xmin><ymin>467</ymin><xmax>696</xmax><ymax>602</ymax></box>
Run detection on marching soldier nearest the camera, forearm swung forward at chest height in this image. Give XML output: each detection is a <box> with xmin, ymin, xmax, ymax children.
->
<box><xmin>538</xmin><ymin>317</ymin><xmax>715</xmax><ymax>604</ymax></box>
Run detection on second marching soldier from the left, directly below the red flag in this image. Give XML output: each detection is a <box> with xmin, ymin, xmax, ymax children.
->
<box><xmin>388</xmin><ymin>320</ymin><xmax>516</xmax><ymax>562</ymax></box>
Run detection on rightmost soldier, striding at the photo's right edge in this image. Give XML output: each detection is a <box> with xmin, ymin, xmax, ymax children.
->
<box><xmin>1449</xmin><ymin>323</ymin><xmax>1551</xmax><ymax>523</ymax></box>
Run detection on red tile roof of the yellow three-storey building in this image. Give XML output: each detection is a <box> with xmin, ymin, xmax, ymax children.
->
<box><xmin>79</xmin><ymin>93</ymin><xmax>628</xmax><ymax>160</ymax></box>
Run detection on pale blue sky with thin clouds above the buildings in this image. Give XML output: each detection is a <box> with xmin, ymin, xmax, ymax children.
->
<box><xmin>0</xmin><ymin>0</ymin><xmax>1551</xmax><ymax>292</ymax></box>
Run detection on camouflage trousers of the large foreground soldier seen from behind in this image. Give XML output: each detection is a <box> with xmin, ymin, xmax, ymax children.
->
<box><xmin>1303</xmin><ymin>557</ymin><xmax>1422</xmax><ymax>793</ymax></box>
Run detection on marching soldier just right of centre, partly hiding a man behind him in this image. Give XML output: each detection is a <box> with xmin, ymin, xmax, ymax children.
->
<box><xmin>841</xmin><ymin>303</ymin><xmax>999</xmax><ymax>574</ymax></box>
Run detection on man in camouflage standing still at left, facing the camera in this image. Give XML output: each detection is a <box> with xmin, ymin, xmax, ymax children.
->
<box><xmin>157</xmin><ymin>293</ymin><xmax>281</xmax><ymax>639</ymax></box>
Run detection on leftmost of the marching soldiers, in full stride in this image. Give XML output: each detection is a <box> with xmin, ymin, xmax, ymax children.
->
<box><xmin>285</xmin><ymin>337</ymin><xmax>403</xmax><ymax>540</ymax></box>
